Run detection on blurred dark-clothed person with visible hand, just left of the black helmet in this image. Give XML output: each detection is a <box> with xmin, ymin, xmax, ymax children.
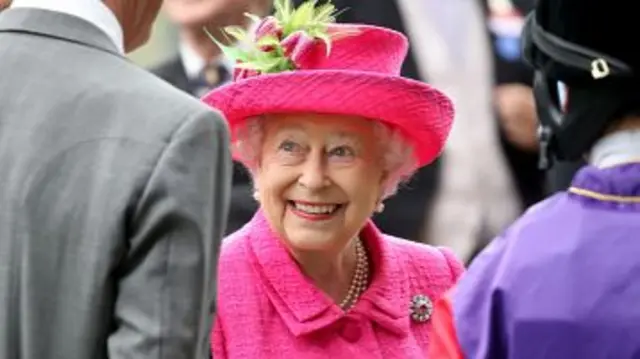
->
<box><xmin>487</xmin><ymin>0</ymin><xmax>585</xmax><ymax>200</ymax></box>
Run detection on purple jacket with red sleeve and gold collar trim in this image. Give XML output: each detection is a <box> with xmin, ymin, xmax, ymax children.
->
<box><xmin>432</xmin><ymin>164</ymin><xmax>640</xmax><ymax>359</ymax></box>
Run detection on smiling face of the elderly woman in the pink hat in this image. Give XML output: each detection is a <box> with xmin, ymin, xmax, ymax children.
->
<box><xmin>255</xmin><ymin>114</ymin><xmax>384</xmax><ymax>252</ymax></box>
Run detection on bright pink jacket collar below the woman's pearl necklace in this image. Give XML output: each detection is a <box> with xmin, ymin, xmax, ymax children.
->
<box><xmin>248</xmin><ymin>211</ymin><xmax>410</xmax><ymax>336</ymax></box>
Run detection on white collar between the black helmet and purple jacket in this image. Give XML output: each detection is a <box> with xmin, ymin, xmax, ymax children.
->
<box><xmin>590</xmin><ymin>130</ymin><xmax>640</xmax><ymax>168</ymax></box>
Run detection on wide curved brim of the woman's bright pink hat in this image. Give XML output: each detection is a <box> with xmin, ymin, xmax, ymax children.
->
<box><xmin>202</xmin><ymin>70</ymin><xmax>454</xmax><ymax>167</ymax></box>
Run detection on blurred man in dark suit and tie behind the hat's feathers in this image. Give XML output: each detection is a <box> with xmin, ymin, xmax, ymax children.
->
<box><xmin>152</xmin><ymin>0</ymin><xmax>273</xmax><ymax>233</ymax></box>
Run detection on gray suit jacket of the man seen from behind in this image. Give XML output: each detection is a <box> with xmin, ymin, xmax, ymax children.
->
<box><xmin>0</xmin><ymin>8</ymin><xmax>231</xmax><ymax>359</ymax></box>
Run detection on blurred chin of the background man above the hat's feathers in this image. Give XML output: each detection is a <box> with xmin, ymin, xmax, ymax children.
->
<box><xmin>164</xmin><ymin>0</ymin><xmax>273</xmax><ymax>29</ymax></box>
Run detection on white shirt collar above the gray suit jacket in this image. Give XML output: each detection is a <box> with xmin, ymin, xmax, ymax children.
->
<box><xmin>11</xmin><ymin>0</ymin><xmax>124</xmax><ymax>54</ymax></box>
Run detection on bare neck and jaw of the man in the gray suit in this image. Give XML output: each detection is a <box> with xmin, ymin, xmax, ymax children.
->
<box><xmin>103</xmin><ymin>0</ymin><xmax>162</xmax><ymax>52</ymax></box>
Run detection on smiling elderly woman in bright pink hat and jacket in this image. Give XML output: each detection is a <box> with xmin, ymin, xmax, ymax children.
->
<box><xmin>203</xmin><ymin>2</ymin><xmax>463</xmax><ymax>359</ymax></box>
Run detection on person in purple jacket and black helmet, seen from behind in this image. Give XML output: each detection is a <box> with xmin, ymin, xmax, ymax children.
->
<box><xmin>429</xmin><ymin>0</ymin><xmax>640</xmax><ymax>359</ymax></box>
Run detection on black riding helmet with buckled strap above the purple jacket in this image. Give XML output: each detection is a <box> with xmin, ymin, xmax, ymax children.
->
<box><xmin>523</xmin><ymin>0</ymin><xmax>640</xmax><ymax>167</ymax></box>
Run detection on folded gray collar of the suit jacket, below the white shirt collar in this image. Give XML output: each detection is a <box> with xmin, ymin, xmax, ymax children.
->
<box><xmin>0</xmin><ymin>8</ymin><xmax>122</xmax><ymax>57</ymax></box>
